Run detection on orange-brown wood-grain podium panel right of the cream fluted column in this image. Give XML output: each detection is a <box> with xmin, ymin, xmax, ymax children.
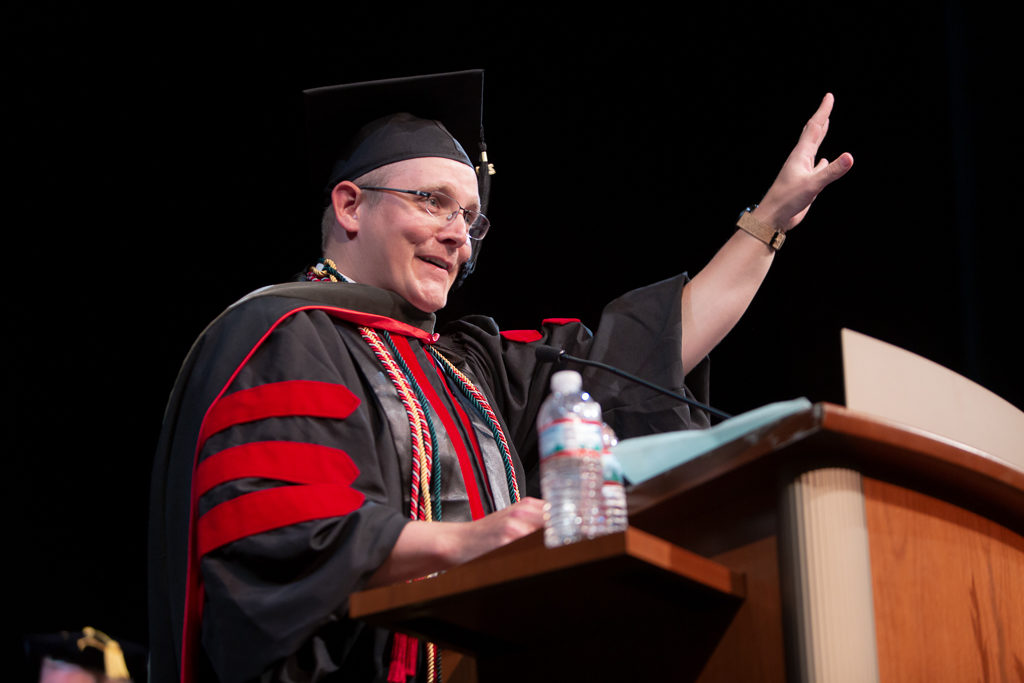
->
<box><xmin>863</xmin><ymin>478</ymin><xmax>1024</xmax><ymax>681</ymax></box>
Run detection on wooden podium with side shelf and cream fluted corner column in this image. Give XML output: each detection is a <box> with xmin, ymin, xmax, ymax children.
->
<box><xmin>350</xmin><ymin>403</ymin><xmax>1024</xmax><ymax>682</ymax></box>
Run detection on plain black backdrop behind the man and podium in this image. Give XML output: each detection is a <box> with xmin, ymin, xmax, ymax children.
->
<box><xmin>0</xmin><ymin>0</ymin><xmax>1024</xmax><ymax>679</ymax></box>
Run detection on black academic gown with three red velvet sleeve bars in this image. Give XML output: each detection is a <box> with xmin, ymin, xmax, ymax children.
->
<box><xmin>150</xmin><ymin>275</ymin><xmax>709</xmax><ymax>683</ymax></box>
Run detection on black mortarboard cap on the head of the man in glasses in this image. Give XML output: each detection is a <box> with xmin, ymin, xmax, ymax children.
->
<box><xmin>304</xmin><ymin>70</ymin><xmax>483</xmax><ymax>204</ymax></box>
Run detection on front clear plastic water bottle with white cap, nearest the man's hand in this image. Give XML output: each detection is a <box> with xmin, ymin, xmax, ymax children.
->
<box><xmin>537</xmin><ymin>370</ymin><xmax>603</xmax><ymax>548</ymax></box>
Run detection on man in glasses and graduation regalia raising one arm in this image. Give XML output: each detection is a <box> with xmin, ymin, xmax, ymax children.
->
<box><xmin>150</xmin><ymin>72</ymin><xmax>853</xmax><ymax>683</ymax></box>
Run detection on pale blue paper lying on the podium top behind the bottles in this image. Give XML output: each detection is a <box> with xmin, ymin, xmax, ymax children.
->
<box><xmin>612</xmin><ymin>398</ymin><xmax>811</xmax><ymax>483</ymax></box>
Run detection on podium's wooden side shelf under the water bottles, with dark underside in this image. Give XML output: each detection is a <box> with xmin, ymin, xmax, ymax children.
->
<box><xmin>349</xmin><ymin>528</ymin><xmax>745</xmax><ymax>681</ymax></box>
